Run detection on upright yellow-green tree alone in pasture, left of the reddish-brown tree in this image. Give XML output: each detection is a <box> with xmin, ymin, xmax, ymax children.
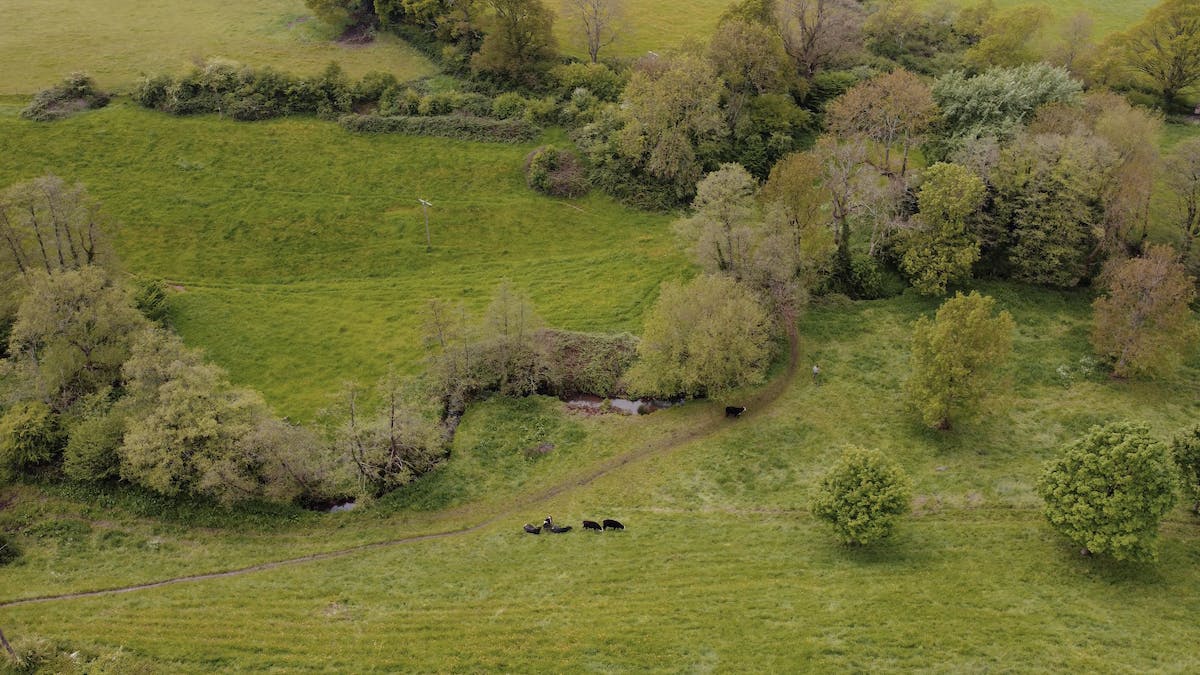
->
<box><xmin>907</xmin><ymin>291</ymin><xmax>1013</xmax><ymax>430</ymax></box>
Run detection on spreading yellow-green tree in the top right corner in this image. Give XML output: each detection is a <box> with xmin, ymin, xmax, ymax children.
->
<box><xmin>1118</xmin><ymin>0</ymin><xmax>1200</xmax><ymax>108</ymax></box>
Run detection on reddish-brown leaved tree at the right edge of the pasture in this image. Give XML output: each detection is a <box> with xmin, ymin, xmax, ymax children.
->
<box><xmin>1092</xmin><ymin>245</ymin><xmax>1196</xmax><ymax>377</ymax></box>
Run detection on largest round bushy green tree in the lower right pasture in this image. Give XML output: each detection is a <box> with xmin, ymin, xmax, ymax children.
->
<box><xmin>1037</xmin><ymin>423</ymin><xmax>1177</xmax><ymax>561</ymax></box>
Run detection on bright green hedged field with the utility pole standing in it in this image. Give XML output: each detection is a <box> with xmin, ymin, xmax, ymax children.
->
<box><xmin>0</xmin><ymin>103</ymin><xmax>688</xmax><ymax>418</ymax></box>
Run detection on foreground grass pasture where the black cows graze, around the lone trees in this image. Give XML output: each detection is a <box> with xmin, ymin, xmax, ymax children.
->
<box><xmin>0</xmin><ymin>285</ymin><xmax>1200</xmax><ymax>673</ymax></box>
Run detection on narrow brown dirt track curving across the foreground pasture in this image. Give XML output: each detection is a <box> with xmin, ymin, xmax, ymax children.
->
<box><xmin>0</xmin><ymin>324</ymin><xmax>800</xmax><ymax>609</ymax></box>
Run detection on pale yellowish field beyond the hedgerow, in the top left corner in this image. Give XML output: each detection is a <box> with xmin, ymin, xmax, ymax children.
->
<box><xmin>0</xmin><ymin>0</ymin><xmax>434</xmax><ymax>94</ymax></box>
